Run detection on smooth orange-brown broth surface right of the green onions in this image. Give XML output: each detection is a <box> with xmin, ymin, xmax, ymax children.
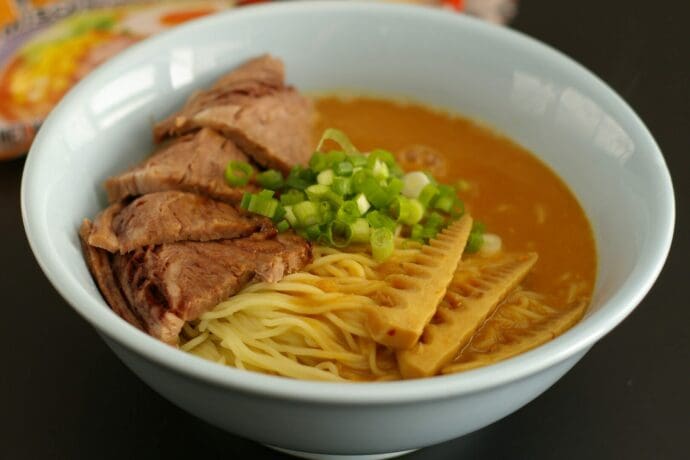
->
<box><xmin>315</xmin><ymin>96</ymin><xmax>596</xmax><ymax>361</ymax></box>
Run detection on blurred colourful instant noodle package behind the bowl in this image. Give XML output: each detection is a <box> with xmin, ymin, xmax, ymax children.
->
<box><xmin>0</xmin><ymin>0</ymin><xmax>514</xmax><ymax>159</ymax></box>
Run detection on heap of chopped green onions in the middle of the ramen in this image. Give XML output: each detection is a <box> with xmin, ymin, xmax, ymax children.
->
<box><xmin>231</xmin><ymin>129</ymin><xmax>484</xmax><ymax>260</ymax></box>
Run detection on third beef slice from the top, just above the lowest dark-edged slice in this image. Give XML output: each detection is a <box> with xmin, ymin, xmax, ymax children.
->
<box><xmin>88</xmin><ymin>191</ymin><xmax>276</xmax><ymax>253</ymax></box>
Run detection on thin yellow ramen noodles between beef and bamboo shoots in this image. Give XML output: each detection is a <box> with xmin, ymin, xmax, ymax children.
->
<box><xmin>181</xmin><ymin>239</ymin><xmax>587</xmax><ymax>381</ymax></box>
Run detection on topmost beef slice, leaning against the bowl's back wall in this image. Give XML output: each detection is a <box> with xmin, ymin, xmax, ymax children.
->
<box><xmin>154</xmin><ymin>55</ymin><xmax>314</xmax><ymax>173</ymax></box>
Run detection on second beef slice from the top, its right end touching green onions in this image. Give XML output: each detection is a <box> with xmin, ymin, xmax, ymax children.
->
<box><xmin>105</xmin><ymin>129</ymin><xmax>257</xmax><ymax>203</ymax></box>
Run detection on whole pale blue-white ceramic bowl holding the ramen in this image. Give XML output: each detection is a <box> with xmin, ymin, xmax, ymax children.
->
<box><xmin>22</xmin><ymin>2</ymin><xmax>674</xmax><ymax>454</ymax></box>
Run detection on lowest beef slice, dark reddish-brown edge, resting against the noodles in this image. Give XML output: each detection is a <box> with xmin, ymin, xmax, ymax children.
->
<box><xmin>107</xmin><ymin>234</ymin><xmax>311</xmax><ymax>344</ymax></box>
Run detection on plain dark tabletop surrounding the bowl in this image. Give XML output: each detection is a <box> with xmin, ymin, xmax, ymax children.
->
<box><xmin>0</xmin><ymin>0</ymin><xmax>690</xmax><ymax>460</ymax></box>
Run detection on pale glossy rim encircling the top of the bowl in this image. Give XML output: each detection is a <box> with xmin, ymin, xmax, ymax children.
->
<box><xmin>21</xmin><ymin>1</ymin><xmax>675</xmax><ymax>405</ymax></box>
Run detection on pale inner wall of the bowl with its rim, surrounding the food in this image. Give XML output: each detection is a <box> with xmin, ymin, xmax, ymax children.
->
<box><xmin>22</xmin><ymin>2</ymin><xmax>673</xmax><ymax>398</ymax></box>
